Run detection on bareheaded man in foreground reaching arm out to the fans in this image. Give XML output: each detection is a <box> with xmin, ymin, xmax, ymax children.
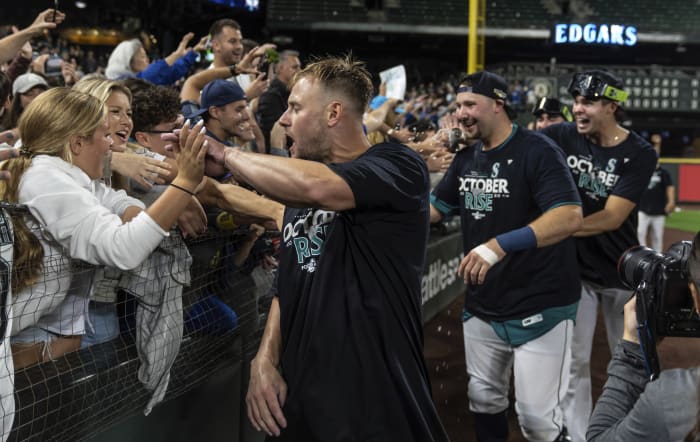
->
<box><xmin>200</xmin><ymin>57</ymin><xmax>447</xmax><ymax>442</ymax></box>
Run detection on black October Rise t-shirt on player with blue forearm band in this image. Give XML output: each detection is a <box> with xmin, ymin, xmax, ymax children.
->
<box><xmin>431</xmin><ymin>126</ymin><xmax>581</xmax><ymax>321</ymax></box>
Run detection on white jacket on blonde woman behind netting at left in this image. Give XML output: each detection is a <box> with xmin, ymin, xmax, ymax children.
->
<box><xmin>10</xmin><ymin>155</ymin><xmax>168</xmax><ymax>335</ymax></box>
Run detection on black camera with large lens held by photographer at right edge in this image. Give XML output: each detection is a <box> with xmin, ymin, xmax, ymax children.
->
<box><xmin>617</xmin><ymin>241</ymin><xmax>700</xmax><ymax>339</ymax></box>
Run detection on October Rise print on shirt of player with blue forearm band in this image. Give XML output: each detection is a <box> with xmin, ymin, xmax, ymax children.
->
<box><xmin>459</xmin><ymin>163</ymin><xmax>510</xmax><ymax>220</ymax></box>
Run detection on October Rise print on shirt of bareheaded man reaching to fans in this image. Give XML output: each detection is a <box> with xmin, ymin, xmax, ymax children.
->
<box><xmin>282</xmin><ymin>209</ymin><xmax>336</xmax><ymax>273</ymax></box>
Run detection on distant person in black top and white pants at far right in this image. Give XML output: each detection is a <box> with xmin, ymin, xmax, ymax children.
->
<box><xmin>637</xmin><ymin>134</ymin><xmax>676</xmax><ymax>252</ymax></box>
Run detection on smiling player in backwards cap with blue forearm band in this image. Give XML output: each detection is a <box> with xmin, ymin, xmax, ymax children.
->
<box><xmin>430</xmin><ymin>72</ymin><xmax>582</xmax><ymax>441</ymax></box>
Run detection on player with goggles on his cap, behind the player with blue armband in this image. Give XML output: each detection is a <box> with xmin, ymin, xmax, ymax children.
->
<box><xmin>542</xmin><ymin>71</ymin><xmax>656</xmax><ymax>442</ymax></box>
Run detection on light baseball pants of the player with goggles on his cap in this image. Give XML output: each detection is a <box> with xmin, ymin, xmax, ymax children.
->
<box><xmin>563</xmin><ymin>281</ymin><xmax>632</xmax><ymax>442</ymax></box>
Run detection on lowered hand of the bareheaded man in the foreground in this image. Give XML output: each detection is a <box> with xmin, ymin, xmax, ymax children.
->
<box><xmin>245</xmin><ymin>356</ymin><xmax>287</xmax><ymax>436</ymax></box>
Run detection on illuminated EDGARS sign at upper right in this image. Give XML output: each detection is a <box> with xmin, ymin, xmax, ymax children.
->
<box><xmin>554</xmin><ymin>23</ymin><xmax>637</xmax><ymax>46</ymax></box>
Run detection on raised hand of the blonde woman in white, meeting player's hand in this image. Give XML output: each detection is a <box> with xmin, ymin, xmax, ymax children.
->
<box><xmin>173</xmin><ymin>120</ymin><xmax>208</xmax><ymax>189</ymax></box>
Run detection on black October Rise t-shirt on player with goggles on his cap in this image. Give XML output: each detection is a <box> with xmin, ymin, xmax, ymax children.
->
<box><xmin>542</xmin><ymin>123</ymin><xmax>656</xmax><ymax>288</ymax></box>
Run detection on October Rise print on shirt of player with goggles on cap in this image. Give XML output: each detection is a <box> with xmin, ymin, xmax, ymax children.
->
<box><xmin>566</xmin><ymin>154</ymin><xmax>629</xmax><ymax>200</ymax></box>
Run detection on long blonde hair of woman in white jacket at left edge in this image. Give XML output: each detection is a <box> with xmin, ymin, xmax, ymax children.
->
<box><xmin>0</xmin><ymin>87</ymin><xmax>107</xmax><ymax>291</ymax></box>
